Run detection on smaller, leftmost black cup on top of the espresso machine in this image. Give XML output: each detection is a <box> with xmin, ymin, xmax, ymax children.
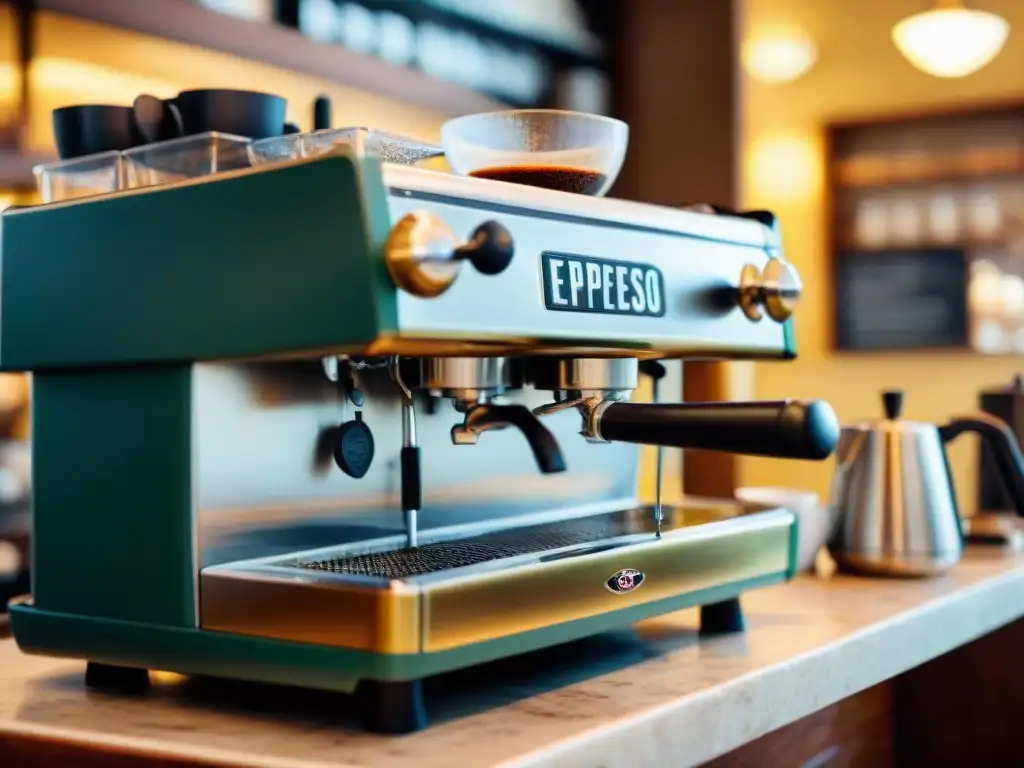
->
<box><xmin>53</xmin><ymin>104</ymin><xmax>143</xmax><ymax>160</ymax></box>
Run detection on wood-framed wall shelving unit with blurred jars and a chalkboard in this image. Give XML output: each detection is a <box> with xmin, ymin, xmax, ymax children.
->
<box><xmin>827</xmin><ymin>104</ymin><xmax>1024</xmax><ymax>355</ymax></box>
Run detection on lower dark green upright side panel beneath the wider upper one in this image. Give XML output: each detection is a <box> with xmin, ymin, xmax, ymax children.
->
<box><xmin>32</xmin><ymin>366</ymin><xmax>197</xmax><ymax>627</ymax></box>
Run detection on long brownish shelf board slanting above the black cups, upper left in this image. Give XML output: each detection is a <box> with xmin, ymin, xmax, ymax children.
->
<box><xmin>36</xmin><ymin>0</ymin><xmax>507</xmax><ymax>116</ymax></box>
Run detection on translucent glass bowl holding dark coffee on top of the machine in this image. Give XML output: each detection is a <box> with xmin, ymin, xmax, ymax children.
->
<box><xmin>441</xmin><ymin>110</ymin><xmax>630</xmax><ymax>197</ymax></box>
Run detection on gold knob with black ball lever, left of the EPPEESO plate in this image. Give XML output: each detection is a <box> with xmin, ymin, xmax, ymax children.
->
<box><xmin>384</xmin><ymin>211</ymin><xmax>514</xmax><ymax>298</ymax></box>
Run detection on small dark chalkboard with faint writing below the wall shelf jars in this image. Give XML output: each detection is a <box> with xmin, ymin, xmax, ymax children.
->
<box><xmin>836</xmin><ymin>249</ymin><xmax>969</xmax><ymax>351</ymax></box>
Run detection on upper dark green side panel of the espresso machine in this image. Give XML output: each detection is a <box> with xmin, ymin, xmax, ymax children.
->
<box><xmin>0</xmin><ymin>155</ymin><xmax>396</xmax><ymax>370</ymax></box>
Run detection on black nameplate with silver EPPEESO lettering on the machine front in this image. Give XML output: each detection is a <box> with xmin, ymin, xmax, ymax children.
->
<box><xmin>541</xmin><ymin>252</ymin><xmax>665</xmax><ymax>317</ymax></box>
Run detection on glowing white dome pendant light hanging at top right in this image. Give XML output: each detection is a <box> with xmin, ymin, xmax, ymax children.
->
<box><xmin>893</xmin><ymin>0</ymin><xmax>1010</xmax><ymax>78</ymax></box>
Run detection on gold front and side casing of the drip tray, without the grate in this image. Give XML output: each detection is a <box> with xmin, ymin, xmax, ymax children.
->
<box><xmin>200</xmin><ymin>510</ymin><xmax>794</xmax><ymax>654</ymax></box>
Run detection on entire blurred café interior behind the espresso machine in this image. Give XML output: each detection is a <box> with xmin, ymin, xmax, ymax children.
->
<box><xmin>0</xmin><ymin>0</ymin><xmax>1024</xmax><ymax>524</ymax></box>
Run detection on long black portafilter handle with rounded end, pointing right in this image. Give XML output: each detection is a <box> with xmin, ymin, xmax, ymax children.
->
<box><xmin>598</xmin><ymin>400</ymin><xmax>840</xmax><ymax>461</ymax></box>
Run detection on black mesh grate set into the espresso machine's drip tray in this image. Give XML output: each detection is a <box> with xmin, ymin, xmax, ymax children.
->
<box><xmin>294</xmin><ymin>514</ymin><xmax>650</xmax><ymax>580</ymax></box>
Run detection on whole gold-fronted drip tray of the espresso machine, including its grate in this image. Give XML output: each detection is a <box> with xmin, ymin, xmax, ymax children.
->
<box><xmin>200</xmin><ymin>505</ymin><xmax>796</xmax><ymax>654</ymax></box>
